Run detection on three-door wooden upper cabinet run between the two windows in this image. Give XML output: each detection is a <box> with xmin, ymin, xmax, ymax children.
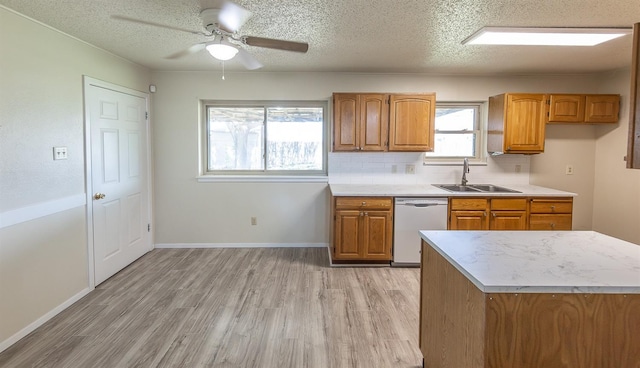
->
<box><xmin>332</xmin><ymin>93</ymin><xmax>435</xmax><ymax>152</ymax></box>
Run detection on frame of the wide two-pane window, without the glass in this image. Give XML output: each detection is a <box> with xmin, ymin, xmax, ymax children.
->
<box><xmin>198</xmin><ymin>100</ymin><xmax>330</xmax><ymax>177</ymax></box>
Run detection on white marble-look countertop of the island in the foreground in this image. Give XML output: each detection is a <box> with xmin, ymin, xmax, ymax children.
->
<box><xmin>420</xmin><ymin>231</ymin><xmax>640</xmax><ymax>294</ymax></box>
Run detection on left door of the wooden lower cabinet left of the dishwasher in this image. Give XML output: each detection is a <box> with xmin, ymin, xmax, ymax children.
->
<box><xmin>334</xmin><ymin>210</ymin><xmax>364</xmax><ymax>259</ymax></box>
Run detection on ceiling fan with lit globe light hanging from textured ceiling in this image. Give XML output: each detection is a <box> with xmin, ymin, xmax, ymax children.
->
<box><xmin>111</xmin><ymin>0</ymin><xmax>309</xmax><ymax>70</ymax></box>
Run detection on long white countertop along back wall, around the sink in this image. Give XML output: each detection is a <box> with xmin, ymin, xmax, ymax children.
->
<box><xmin>329</xmin><ymin>183</ymin><xmax>577</xmax><ymax>197</ymax></box>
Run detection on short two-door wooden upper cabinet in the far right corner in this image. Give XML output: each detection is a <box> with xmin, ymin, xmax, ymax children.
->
<box><xmin>549</xmin><ymin>94</ymin><xmax>620</xmax><ymax>124</ymax></box>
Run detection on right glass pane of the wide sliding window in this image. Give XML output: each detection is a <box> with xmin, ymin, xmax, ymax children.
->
<box><xmin>267</xmin><ymin>107</ymin><xmax>323</xmax><ymax>170</ymax></box>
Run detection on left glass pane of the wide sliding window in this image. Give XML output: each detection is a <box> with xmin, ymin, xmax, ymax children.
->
<box><xmin>208</xmin><ymin>107</ymin><xmax>264</xmax><ymax>170</ymax></box>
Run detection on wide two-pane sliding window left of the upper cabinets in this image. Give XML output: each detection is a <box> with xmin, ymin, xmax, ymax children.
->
<box><xmin>203</xmin><ymin>102</ymin><xmax>327</xmax><ymax>176</ymax></box>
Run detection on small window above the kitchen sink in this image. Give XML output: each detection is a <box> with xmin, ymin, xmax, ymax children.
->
<box><xmin>425</xmin><ymin>103</ymin><xmax>484</xmax><ymax>163</ymax></box>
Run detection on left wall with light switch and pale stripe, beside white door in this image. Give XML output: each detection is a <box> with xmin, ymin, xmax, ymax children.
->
<box><xmin>0</xmin><ymin>7</ymin><xmax>149</xmax><ymax>351</ymax></box>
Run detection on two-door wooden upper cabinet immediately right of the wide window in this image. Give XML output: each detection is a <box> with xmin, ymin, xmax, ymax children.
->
<box><xmin>333</xmin><ymin>93</ymin><xmax>389</xmax><ymax>151</ymax></box>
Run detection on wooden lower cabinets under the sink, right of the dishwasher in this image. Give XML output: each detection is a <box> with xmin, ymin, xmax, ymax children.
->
<box><xmin>449</xmin><ymin>197</ymin><xmax>573</xmax><ymax>230</ymax></box>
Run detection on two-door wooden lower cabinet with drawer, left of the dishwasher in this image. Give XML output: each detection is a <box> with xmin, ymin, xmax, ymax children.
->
<box><xmin>331</xmin><ymin>197</ymin><xmax>393</xmax><ymax>262</ymax></box>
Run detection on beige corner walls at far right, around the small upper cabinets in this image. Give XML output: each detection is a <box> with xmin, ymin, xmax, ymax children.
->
<box><xmin>530</xmin><ymin>69</ymin><xmax>640</xmax><ymax>244</ymax></box>
